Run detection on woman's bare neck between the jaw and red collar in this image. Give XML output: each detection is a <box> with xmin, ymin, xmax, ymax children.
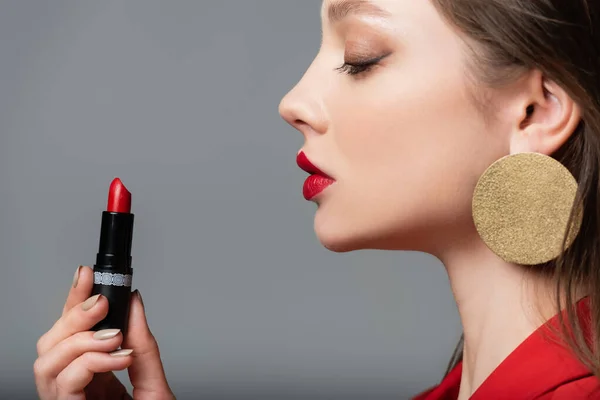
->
<box><xmin>438</xmin><ymin>233</ymin><xmax>556</xmax><ymax>400</ymax></box>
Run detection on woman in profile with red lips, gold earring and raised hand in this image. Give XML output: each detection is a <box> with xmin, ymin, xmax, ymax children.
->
<box><xmin>34</xmin><ymin>0</ymin><xmax>600</xmax><ymax>400</ymax></box>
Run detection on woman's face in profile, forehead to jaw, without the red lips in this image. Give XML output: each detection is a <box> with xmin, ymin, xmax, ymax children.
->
<box><xmin>280</xmin><ymin>0</ymin><xmax>508</xmax><ymax>252</ymax></box>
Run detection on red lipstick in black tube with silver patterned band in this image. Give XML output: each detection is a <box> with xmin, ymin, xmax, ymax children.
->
<box><xmin>92</xmin><ymin>178</ymin><xmax>134</xmax><ymax>334</ymax></box>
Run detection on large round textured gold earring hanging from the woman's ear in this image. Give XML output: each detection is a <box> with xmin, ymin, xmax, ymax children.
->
<box><xmin>472</xmin><ymin>153</ymin><xmax>582</xmax><ymax>265</ymax></box>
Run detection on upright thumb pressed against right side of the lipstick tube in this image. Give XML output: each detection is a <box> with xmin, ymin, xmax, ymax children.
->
<box><xmin>122</xmin><ymin>289</ymin><xmax>175</xmax><ymax>399</ymax></box>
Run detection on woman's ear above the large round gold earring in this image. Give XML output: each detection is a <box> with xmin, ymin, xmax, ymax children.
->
<box><xmin>510</xmin><ymin>70</ymin><xmax>581</xmax><ymax>155</ymax></box>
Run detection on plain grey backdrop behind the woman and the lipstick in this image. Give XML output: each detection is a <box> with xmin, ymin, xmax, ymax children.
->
<box><xmin>0</xmin><ymin>0</ymin><xmax>460</xmax><ymax>400</ymax></box>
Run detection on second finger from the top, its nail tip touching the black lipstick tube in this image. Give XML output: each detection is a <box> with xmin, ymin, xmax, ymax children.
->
<box><xmin>37</xmin><ymin>294</ymin><xmax>108</xmax><ymax>356</ymax></box>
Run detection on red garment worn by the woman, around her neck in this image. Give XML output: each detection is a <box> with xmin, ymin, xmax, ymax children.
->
<box><xmin>413</xmin><ymin>298</ymin><xmax>600</xmax><ymax>400</ymax></box>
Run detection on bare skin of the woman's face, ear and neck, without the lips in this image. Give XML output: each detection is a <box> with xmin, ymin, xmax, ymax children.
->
<box><xmin>280</xmin><ymin>0</ymin><xmax>581</xmax><ymax>400</ymax></box>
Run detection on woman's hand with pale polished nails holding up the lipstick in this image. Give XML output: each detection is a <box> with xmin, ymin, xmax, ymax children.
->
<box><xmin>34</xmin><ymin>267</ymin><xmax>175</xmax><ymax>400</ymax></box>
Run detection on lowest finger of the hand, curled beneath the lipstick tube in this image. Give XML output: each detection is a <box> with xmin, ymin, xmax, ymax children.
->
<box><xmin>56</xmin><ymin>349</ymin><xmax>132</xmax><ymax>399</ymax></box>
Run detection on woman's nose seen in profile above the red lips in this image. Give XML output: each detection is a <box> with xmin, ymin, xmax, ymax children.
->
<box><xmin>279</xmin><ymin>64</ymin><xmax>327</xmax><ymax>136</ymax></box>
